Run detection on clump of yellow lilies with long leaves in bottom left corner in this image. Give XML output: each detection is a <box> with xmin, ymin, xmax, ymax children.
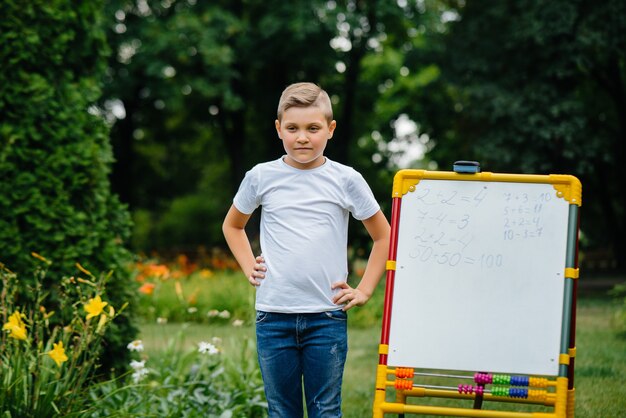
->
<box><xmin>0</xmin><ymin>266</ymin><xmax>123</xmax><ymax>417</ymax></box>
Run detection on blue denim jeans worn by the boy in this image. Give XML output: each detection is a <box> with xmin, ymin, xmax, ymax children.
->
<box><xmin>256</xmin><ymin>310</ymin><xmax>348</xmax><ymax>418</ymax></box>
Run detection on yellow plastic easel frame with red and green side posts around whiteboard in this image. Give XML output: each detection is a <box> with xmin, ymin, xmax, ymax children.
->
<box><xmin>373</xmin><ymin>170</ymin><xmax>582</xmax><ymax>418</ymax></box>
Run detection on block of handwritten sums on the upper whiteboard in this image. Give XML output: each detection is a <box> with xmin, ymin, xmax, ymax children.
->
<box><xmin>408</xmin><ymin>185</ymin><xmax>554</xmax><ymax>269</ymax></box>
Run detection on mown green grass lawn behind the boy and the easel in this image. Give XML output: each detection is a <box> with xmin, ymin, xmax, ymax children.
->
<box><xmin>141</xmin><ymin>298</ymin><xmax>626</xmax><ymax>418</ymax></box>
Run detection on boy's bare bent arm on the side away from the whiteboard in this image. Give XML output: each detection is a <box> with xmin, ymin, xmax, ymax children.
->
<box><xmin>222</xmin><ymin>205</ymin><xmax>265</xmax><ymax>286</ymax></box>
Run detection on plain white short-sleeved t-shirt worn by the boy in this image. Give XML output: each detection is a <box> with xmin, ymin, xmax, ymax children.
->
<box><xmin>233</xmin><ymin>157</ymin><xmax>380</xmax><ymax>313</ymax></box>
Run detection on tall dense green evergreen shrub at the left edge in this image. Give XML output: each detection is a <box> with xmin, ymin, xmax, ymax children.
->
<box><xmin>0</xmin><ymin>0</ymin><xmax>136</xmax><ymax>372</ymax></box>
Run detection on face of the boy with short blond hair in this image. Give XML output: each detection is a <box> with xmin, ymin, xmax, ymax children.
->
<box><xmin>275</xmin><ymin>106</ymin><xmax>337</xmax><ymax>170</ymax></box>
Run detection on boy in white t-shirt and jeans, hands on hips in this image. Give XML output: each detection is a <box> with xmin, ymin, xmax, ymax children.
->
<box><xmin>223</xmin><ymin>83</ymin><xmax>390</xmax><ymax>418</ymax></box>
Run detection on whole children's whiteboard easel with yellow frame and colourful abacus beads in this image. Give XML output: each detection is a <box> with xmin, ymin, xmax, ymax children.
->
<box><xmin>373</xmin><ymin>167</ymin><xmax>581</xmax><ymax>418</ymax></box>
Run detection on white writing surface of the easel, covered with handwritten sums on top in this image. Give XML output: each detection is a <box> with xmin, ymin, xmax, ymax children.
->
<box><xmin>388</xmin><ymin>179</ymin><xmax>569</xmax><ymax>376</ymax></box>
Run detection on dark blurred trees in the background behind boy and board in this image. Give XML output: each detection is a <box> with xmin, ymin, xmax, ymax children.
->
<box><xmin>95</xmin><ymin>0</ymin><xmax>626</xmax><ymax>272</ymax></box>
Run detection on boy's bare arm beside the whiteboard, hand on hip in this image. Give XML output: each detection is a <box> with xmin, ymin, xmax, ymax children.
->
<box><xmin>333</xmin><ymin>210</ymin><xmax>391</xmax><ymax>311</ymax></box>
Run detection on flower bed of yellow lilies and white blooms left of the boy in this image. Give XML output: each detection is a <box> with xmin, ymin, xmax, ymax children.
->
<box><xmin>0</xmin><ymin>260</ymin><xmax>266</xmax><ymax>417</ymax></box>
